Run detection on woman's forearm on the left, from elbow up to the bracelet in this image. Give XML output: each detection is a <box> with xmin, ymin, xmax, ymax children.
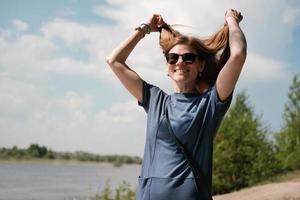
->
<box><xmin>107</xmin><ymin>26</ymin><xmax>146</xmax><ymax>64</ymax></box>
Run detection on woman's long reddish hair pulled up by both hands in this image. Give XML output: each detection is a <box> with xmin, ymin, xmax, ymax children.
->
<box><xmin>159</xmin><ymin>24</ymin><xmax>230</xmax><ymax>90</ymax></box>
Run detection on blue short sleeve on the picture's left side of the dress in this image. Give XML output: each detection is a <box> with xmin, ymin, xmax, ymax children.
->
<box><xmin>138</xmin><ymin>81</ymin><xmax>162</xmax><ymax>112</ymax></box>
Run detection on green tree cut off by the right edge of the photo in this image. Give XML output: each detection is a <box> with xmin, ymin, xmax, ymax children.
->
<box><xmin>276</xmin><ymin>74</ymin><xmax>300</xmax><ymax>170</ymax></box>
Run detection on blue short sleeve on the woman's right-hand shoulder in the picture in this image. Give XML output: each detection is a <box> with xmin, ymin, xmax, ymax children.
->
<box><xmin>211</xmin><ymin>85</ymin><xmax>233</xmax><ymax>118</ymax></box>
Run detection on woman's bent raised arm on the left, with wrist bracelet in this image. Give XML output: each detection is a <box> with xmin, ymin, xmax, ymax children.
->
<box><xmin>107</xmin><ymin>15</ymin><xmax>163</xmax><ymax>101</ymax></box>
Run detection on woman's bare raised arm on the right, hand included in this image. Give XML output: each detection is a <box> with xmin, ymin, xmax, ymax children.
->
<box><xmin>216</xmin><ymin>9</ymin><xmax>247</xmax><ymax>101</ymax></box>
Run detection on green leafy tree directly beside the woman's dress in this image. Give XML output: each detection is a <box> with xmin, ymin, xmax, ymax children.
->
<box><xmin>213</xmin><ymin>92</ymin><xmax>278</xmax><ymax>193</ymax></box>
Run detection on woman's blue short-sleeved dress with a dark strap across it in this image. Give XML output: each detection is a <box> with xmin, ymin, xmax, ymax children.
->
<box><xmin>136</xmin><ymin>82</ymin><xmax>232</xmax><ymax>200</ymax></box>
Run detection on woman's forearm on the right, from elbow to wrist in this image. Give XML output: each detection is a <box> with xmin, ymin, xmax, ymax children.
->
<box><xmin>227</xmin><ymin>20</ymin><xmax>247</xmax><ymax>59</ymax></box>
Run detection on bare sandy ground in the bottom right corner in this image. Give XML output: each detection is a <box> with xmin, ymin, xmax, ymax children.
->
<box><xmin>213</xmin><ymin>180</ymin><xmax>300</xmax><ymax>200</ymax></box>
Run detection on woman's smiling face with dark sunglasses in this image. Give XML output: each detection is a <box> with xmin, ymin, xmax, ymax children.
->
<box><xmin>167</xmin><ymin>44</ymin><xmax>203</xmax><ymax>85</ymax></box>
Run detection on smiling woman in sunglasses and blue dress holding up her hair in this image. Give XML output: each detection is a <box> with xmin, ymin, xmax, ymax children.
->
<box><xmin>107</xmin><ymin>9</ymin><xmax>246</xmax><ymax>200</ymax></box>
